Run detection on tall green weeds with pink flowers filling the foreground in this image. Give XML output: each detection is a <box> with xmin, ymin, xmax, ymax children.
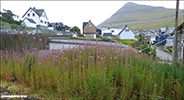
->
<box><xmin>0</xmin><ymin>40</ymin><xmax>184</xmax><ymax>100</ymax></box>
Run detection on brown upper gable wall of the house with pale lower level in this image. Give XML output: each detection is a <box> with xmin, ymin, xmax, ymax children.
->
<box><xmin>83</xmin><ymin>22</ymin><xmax>96</xmax><ymax>34</ymax></box>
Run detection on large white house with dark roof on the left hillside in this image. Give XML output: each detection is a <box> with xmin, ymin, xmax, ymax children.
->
<box><xmin>22</xmin><ymin>7</ymin><xmax>48</xmax><ymax>28</ymax></box>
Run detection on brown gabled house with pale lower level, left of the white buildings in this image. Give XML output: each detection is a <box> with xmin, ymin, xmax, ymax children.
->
<box><xmin>83</xmin><ymin>20</ymin><xmax>96</xmax><ymax>39</ymax></box>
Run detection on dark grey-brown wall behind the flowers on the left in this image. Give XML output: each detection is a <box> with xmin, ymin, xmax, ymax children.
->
<box><xmin>0</xmin><ymin>34</ymin><xmax>72</xmax><ymax>51</ymax></box>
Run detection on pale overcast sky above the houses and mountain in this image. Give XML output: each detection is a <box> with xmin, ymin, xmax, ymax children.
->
<box><xmin>1</xmin><ymin>0</ymin><xmax>184</xmax><ymax>29</ymax></box>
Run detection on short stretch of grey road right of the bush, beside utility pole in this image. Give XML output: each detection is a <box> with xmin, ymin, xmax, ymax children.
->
<box><xmin>156</xmin><ymin>47</ymin><xmax>172</xmax><ymax>61</ymax></box>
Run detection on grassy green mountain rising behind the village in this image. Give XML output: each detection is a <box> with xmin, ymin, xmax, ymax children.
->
<box><xmin>97</xmin><ymin>2</ymin><xmax>184</xmax><ymax>30</ymax></box>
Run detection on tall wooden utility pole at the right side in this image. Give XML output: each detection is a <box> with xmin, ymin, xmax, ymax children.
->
<box><xmin>173</xmin><ymin>0</ymin><xmax>179</xmax><ymax>62</ymax></box>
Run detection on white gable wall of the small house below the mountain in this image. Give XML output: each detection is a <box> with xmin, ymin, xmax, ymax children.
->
<box><xmin>119</xmin><ymin>27</ymin><xmax>135</xmax><ymax>40</ymax></box>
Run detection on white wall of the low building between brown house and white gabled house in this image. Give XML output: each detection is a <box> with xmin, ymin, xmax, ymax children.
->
<box><xmin>102</xmin><ymin>28</ymin><xmax>122</xmax><ymax>36</ymax></box>
